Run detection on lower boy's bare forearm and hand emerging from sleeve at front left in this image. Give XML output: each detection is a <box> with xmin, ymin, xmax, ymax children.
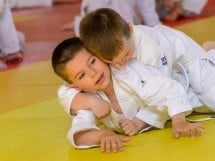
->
<box><xmin>74</xmin><ymin>129</ymin><xmax>130</xmax><ymax>153</ymax></box>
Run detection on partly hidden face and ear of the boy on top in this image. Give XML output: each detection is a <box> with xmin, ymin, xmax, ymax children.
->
<box><xmin>104</xmin><ymin>36</ymin><xmax>135</xmax><ymax>68</ymax></box>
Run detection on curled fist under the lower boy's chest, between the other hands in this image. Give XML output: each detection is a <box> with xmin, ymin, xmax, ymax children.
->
<box><xmin>119</xmin><ymin>119</ymin><xmax>139</xmax><ymax>136</ymax></box>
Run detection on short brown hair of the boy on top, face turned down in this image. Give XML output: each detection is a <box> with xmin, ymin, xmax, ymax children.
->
<box><xmin>80</xmin><ymin>8</ymin><xmax>131</xmax><ymax>61</ymax></box>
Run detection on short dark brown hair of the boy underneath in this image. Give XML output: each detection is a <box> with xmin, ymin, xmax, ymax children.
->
<box><xmin>52</xmin><ymin>37</ymin><xmax>85</xmax><ymax>83</ymax></box>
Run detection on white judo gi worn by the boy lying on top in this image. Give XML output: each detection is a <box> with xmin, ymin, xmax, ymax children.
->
<box><xmin>133</xmin><ymin>25</ymin><xmax>215</xmax><ymax>111</ymax></box>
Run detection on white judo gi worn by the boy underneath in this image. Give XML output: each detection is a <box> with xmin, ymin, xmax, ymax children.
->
<box><xmin>64</xmin><ymin>60</ymin><xmax>192</xmax><ymax>148</ymax></box>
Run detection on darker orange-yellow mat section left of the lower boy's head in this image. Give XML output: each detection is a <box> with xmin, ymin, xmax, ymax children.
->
<box><xmin>0</xmin><ymin>61</ymin><xmax>62</xmax><ymax>113</ymax></box>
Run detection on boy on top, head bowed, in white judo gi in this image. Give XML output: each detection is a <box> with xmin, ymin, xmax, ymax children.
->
<box><xmin>80</xmin><ymin>8</ymin><xmax>215</xmax><ymax>111</ymax></box>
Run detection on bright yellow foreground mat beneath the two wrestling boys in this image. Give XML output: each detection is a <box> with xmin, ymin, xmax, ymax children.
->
<box><xmin>0</xmin><ymin>99</ymin><xmax>215</xmax><ymax>161</ymax></box>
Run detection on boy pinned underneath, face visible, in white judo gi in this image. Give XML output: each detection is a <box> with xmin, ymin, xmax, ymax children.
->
<box><xmin>52</xmin><ymin>38</ymin><xmax>202</xmax><ymax>152</ymax></box>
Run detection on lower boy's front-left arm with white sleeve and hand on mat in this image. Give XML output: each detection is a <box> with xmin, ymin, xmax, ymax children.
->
<box><xmin>70</xmin><ymin>110</ymin><xmax>129</xmax><ymax>152</ymax></box>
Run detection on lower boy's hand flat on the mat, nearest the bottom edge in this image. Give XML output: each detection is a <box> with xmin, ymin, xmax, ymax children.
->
<box><xmin>100</xmin><ymin>132</ymin><xmax>130</xmax><ymax>153</ymax></box>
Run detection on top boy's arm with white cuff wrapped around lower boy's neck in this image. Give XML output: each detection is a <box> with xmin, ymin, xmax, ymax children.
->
<box><xmin>58</xmin><ymin>85</ymin><xmax>110</xmax><ymax>118</ymax></box>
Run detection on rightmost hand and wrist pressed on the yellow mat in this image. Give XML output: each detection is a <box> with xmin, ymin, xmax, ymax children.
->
<box><xmin>172</xmin><ymin>113</ymin><xmax>203</xmax><ymax>138</ymax></box>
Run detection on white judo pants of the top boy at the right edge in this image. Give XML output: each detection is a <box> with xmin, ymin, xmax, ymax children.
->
<box><xmin>188</xmin><ymin>50</ymin><xmax>215</xmax><ymax>112</ymax></box>
